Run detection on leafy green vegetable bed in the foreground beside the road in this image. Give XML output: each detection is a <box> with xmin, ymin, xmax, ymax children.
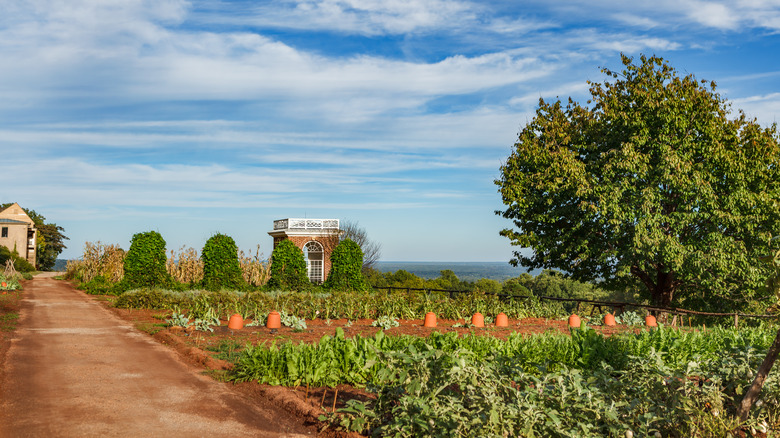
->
<box><xmin>230</xmin><ymin>327</ymin><xmax>780</xmax><ymax>437</ymax></box>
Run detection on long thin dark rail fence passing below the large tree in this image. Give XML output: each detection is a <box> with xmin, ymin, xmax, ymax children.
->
<box><xmin>372</xmin><ymin>286</ymin><xmax>780</xmax><ymax>327</ymax></box>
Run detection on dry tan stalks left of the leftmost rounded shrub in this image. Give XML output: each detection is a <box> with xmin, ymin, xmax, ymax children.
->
<box><xmin>66</xmin><ymin>241</ymin><xmax>125</xmax><ymax>283</ymax></box>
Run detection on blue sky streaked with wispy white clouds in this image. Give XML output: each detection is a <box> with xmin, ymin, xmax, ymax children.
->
<box><xmin>0</xmin><ymin>0</ymin><xmax>780</xmax><ymax>261</ymax></box>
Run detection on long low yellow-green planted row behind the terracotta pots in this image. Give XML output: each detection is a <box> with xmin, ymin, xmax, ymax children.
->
<box><xmin>114</xmin><ymin>288</ymin><xmax>568</xmax><ymax>322</ymax></box>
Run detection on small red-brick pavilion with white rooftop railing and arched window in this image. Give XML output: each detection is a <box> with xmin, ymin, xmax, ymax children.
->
<box><xmin>268</xmin><ymin>218</ymin><xmax>342</xmax><ymax>283</ymax></box>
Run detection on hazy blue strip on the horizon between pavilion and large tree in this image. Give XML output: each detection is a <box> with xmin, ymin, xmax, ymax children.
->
<box><xmin>376</xmin><ymin>262</ymin><xmax>540</xmax><ymax>281</ymax></box>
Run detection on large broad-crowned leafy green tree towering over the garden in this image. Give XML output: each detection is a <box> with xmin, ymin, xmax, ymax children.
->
<box><xmin>496</xmin><ymin>56</ymin><xmax>780</xmax><ymax>309</ymax></box>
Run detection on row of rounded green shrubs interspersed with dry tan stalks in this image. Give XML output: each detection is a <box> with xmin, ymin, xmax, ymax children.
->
<box><xmin>67</xmin><ymin>231</ymin><xmax>369</xmax><ymax>295</ymax></box>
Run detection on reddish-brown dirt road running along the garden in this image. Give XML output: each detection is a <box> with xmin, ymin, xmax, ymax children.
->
<box><xmin>0</xmin><ymin>276</ymin><xmax>312</xmax><ymax>437</ymax></box>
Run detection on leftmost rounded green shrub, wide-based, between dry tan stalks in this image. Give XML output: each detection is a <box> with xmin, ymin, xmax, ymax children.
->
<box><xmin>117</xmin><ymin>231</ymin><xmax>173</xmax><ymax>291</ymax></box>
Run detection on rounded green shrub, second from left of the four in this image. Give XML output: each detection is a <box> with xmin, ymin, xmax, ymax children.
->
<box><xmin>201</xmin><ymin>233</ymin><xmax>246</xmax><ymax>290</ymax></box>
